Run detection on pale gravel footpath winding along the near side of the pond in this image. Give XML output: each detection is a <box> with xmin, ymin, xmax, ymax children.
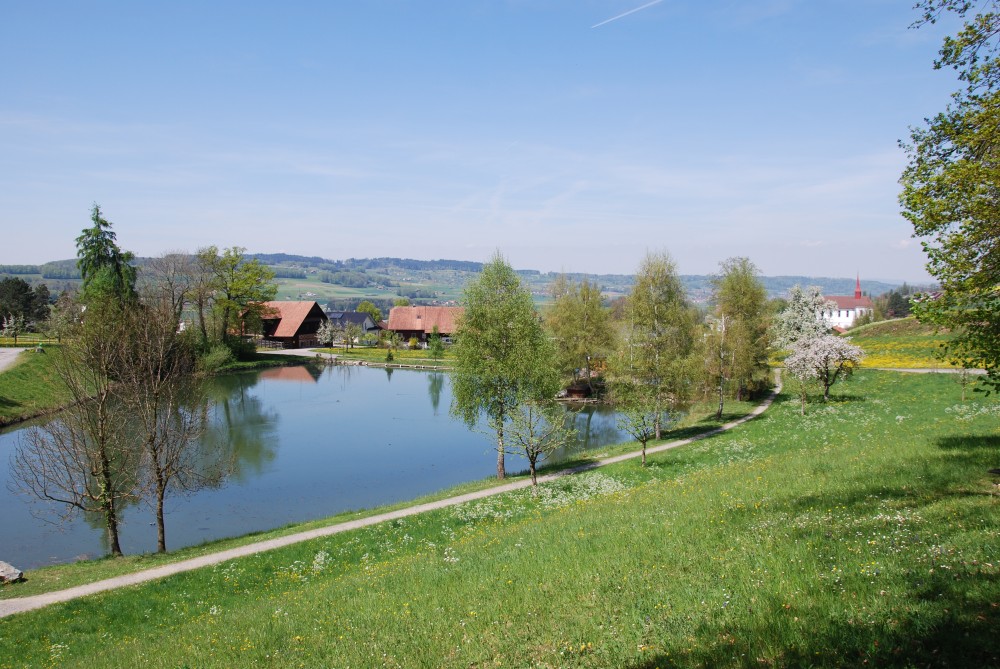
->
<box><xmin>0</xmin><ymin>371</ymin><xmax>781</xmax><ymax>618</ymax></box>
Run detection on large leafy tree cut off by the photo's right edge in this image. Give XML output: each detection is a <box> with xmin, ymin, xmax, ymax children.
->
<box><xmin>900</xmin><ymin>0</ymin><xmax>1000</xmax><ymax>389</ymax></box>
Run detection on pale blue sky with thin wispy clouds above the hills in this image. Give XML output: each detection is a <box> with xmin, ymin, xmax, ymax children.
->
<box><xmin>0</xmin><ymin>0</ymin><xmax>958</xmax><ymax>282</ymax></box>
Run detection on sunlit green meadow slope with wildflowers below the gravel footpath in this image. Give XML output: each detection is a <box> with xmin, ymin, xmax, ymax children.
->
<box><xmin>0</xmin><ymin>371</ymin><xmax>1000</xmax><ymax>669</ymax></box>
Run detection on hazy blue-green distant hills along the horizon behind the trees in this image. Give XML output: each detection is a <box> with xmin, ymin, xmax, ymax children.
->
<box><xmin>0</xmin><ymin>253</ymin><xmax>916</xmax><ymax>308</ymax></box>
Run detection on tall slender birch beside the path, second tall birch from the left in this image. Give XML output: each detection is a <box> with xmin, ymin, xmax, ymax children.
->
<box><xmin>611</xmin><ymin>253</ymin><xmax>697</xmax><ymax>439</ymax></box>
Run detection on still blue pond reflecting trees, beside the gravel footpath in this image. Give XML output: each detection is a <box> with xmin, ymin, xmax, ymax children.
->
<box><xmin>0</xmin><ymin>366</ymin><xmax>626</xmax><ymax>569</ymax></box>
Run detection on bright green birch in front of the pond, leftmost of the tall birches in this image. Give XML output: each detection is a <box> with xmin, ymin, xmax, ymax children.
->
<box><xmin>451</xmin><ymin>252</ymin><xmax>558</xmax><ymax>479</ymax></box>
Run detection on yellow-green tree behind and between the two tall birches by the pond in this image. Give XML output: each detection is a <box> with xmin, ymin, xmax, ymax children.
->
<box><xmin>545</xmin><ymin>274</ymin><xmax>613</xmax><ymax>389</ymax></box>
